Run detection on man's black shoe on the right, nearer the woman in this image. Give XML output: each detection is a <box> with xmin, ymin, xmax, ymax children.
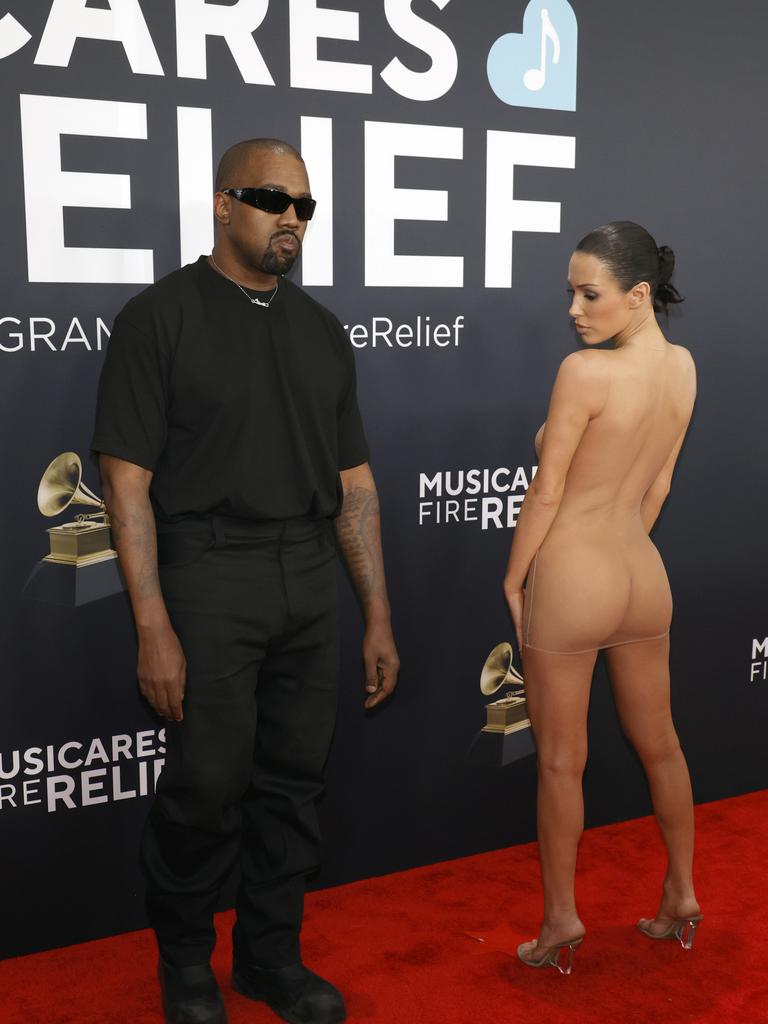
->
<box><xmin>232</xmin><ymin>962</ymin><xmax>347</xmax><ymax>1024</ymax></box>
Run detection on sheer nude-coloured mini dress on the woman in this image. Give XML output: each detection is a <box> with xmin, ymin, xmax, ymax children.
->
<box><xmin>523</xmin><ymin>343</ymin><xmax>695</xmax><ymax>654</ymax></box>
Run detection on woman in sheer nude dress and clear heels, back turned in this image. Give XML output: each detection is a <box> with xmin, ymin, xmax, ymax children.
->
<box><xmin>504</xmin><ymin>221</ymin><xmax>701</xmax><ymax>973</ymax></box>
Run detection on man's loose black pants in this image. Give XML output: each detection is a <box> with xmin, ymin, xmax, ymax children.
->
<box><xmin>141</xmin><ymin>518</ymin><xmax>339</xmax><ymax>968</ymax></box>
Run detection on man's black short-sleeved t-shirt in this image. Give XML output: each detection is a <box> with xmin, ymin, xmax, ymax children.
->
<box><xmin>91</xmin><ymin>256</ymin><xmax>368</xmax><ymax>522</ymax></box>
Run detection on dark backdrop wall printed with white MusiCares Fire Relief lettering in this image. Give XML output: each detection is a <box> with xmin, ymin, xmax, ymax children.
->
<box><xmin>0</xmin><ymin>0</ymin><xmax>768</xmax><ymax>955</ymax></box>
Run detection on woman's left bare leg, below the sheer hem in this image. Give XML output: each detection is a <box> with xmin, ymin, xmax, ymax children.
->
<box><xmin>523</xmin><ymin>647</ymin><xmax>596</xmax><ymax>959</ymax></box>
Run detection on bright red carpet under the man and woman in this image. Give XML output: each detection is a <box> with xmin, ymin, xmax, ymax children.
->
<box><xmin>0</xmin><ymin>792</ymin><xmax>768</xmax><ymax>1024</ymax></box>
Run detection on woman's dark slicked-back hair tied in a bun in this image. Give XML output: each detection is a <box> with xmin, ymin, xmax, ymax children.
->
<box><xmin>577</xmin><ymin>220</ymin><xmax>683</xmax><ymax>313</ymax></box>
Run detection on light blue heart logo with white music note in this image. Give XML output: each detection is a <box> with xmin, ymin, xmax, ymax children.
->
<box><xmin>487</xmin><ymin>0</ymin><xmax>579</xmax><ymax>111</ymax></box>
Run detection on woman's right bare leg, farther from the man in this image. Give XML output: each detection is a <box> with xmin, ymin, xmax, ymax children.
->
<box><xmin>606</xmin><ymin>637</ymin><xmax>699</xmax><ymax>932</ymax></box>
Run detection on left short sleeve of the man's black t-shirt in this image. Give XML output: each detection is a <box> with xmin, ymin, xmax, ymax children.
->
<box><xmin>91</xmin><ymin>314</ymin><xmax>170</xmax><ymax>471</ymax></box>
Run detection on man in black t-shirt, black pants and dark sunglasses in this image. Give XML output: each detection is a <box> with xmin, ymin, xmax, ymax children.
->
<box><xmin>92</xmin><ymin>139</ymin><xmax>398</xmax><ymax>1024</ymax></box>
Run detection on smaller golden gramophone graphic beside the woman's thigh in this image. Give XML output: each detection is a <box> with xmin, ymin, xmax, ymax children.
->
<box><xmin>469</xmin><ymin>643</ymin><xmax>536</xmax><ymax>767</ymax></box>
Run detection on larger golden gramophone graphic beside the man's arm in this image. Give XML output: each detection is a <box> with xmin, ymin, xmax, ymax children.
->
<box><xmin>24</xmin><ymin>452</ymin><xmax>125</xmax><ymax>605</ymax></box>
